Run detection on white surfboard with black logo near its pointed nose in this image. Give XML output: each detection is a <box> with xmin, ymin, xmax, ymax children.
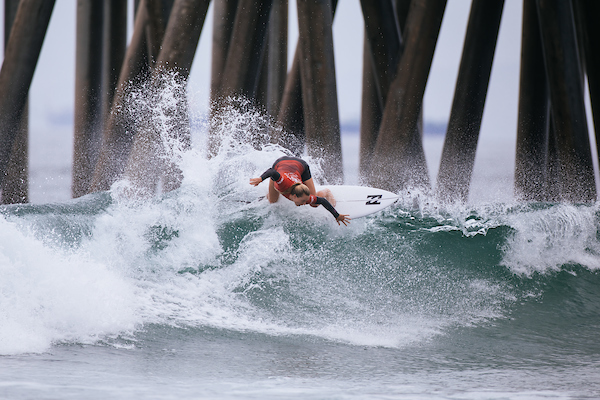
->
<box><xmin>316</xmin><ymin>185</ymin><xmax>399</xmax><ymax>218</ymax></box>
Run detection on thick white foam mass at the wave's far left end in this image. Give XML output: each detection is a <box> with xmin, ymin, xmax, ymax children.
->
<box><xmin>0</xmin><ymin>218</ymin><xmax>137</xmax><ymax>354</ymax></box>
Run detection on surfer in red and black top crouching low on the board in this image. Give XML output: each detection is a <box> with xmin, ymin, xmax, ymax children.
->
<box><xmin>250</xmin><ymin>157</ymin><xmax>350</xmax><ymax>226</ymax></box>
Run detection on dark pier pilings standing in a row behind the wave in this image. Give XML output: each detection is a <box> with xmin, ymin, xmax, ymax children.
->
<box><xmin>0</xmin><ymin>0</ymin><xmax>600</xmax><ymax>204</ymax></box>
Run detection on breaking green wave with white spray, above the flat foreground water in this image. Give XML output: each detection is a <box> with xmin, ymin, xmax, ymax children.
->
<box><xmin>0</xmin><ymin>104</ymin><xmax>600</xmax><ymax>360</ymax></box>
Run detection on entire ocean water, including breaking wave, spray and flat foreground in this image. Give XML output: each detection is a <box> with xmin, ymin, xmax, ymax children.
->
<box><xmin>0</xmin><ymin>97</ymin><xmax>600</xmax><ymax>399</ymax></box>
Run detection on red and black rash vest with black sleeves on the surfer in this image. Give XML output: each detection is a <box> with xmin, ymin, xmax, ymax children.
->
<box><xmin>260</xmin><ymin>157</ymin><xmax>340</xmax><ymax>219</ymax></box>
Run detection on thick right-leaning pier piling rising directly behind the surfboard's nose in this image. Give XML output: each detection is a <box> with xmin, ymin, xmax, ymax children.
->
<box><xmin>369</xmin><ymin>0</ymin><xmax>446</xmax><ymax>191</ymax></box>
